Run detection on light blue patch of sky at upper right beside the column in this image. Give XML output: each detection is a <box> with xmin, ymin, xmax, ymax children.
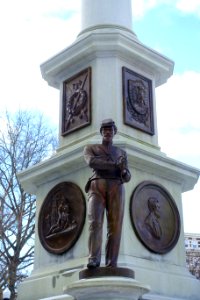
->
<box><xmin>133</xmin><ymin>4</ymin><xmax>200</xmax><ymax>73</ymax></box>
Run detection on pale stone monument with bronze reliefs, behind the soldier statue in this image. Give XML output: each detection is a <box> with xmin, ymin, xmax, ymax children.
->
<box><xmin>18</xmin><ymin>0</ymin><xmax>200</xmax><ymax>300</ymax></box>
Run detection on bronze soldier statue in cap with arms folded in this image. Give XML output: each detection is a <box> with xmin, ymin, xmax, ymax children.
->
<box><xmin>84</xmin><ymin>119</ymin><xmax>131</xmax><ymax>268</ymax></box>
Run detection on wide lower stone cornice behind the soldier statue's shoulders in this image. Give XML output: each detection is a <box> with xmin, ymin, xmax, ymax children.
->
<box><xmin>18</xmin><ymin>138</ymin><xmax>200</xmax><ymax>194</ymax></box>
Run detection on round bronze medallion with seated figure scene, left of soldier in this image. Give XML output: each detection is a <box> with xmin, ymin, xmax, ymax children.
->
<box><xmin>38</xmin><ymin>182</ymin><xmax>86</xmax><ymax>254</ymax></box>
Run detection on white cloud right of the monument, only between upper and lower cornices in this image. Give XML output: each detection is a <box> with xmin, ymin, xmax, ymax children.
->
<box><xmin>156</xmin><ymin>71</ymin><xmax>200</xmax><ymax>167</ymax></box>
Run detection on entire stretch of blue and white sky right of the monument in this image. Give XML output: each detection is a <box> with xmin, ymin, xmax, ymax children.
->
<box><xmin>133</xmin><ymin>0</ymin><xmax>200</xmax><ymax>233</ymax></box>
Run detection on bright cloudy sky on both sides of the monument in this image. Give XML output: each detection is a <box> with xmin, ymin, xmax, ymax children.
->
<box><xmin>0</xmin><ymin>0</ymin><xmax>200</xmax><ymax>233</ymax></box>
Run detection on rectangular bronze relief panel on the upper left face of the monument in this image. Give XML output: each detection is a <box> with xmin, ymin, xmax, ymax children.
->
<box><xmin>62</xmin><ymin>68</ymin><xmax>91</xmax><ymax>136</ymax></box>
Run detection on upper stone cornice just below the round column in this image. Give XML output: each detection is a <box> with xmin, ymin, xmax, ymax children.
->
<box><xmin>41</xmin><ymin>28</ymin><xmax>174</xmax><ymax>89</ymax></box>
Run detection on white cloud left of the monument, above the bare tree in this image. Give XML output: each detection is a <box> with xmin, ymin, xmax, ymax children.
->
<box><xmin>0</xmin><ymin>0</ymin><xmax>80</xmax><ymax>122</ymax></box>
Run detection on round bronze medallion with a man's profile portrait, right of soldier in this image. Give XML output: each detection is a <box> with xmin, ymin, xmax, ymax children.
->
<box><xmin>130</xmin><ymin>181</ymin><xmax>180</xmax><ymax>254</ymax></box>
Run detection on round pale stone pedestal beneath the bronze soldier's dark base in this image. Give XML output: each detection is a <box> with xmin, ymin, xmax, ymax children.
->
<box><xmin>65</xmin><ymin>276</ymin><xmax>149</xmax><ymax>300</ymax></box>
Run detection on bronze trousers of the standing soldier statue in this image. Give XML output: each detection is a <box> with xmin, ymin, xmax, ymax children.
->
<box><xmin>88</xmin><ymin>179</ymin><xmax>124</xmax><ymax>267</ymax></box>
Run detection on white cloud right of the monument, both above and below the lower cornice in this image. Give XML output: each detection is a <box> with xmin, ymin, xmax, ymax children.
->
<box><xmin>156</xmin><ymin>71</ymin><xmax>200</xmax><ymax>233</ymax></box>
